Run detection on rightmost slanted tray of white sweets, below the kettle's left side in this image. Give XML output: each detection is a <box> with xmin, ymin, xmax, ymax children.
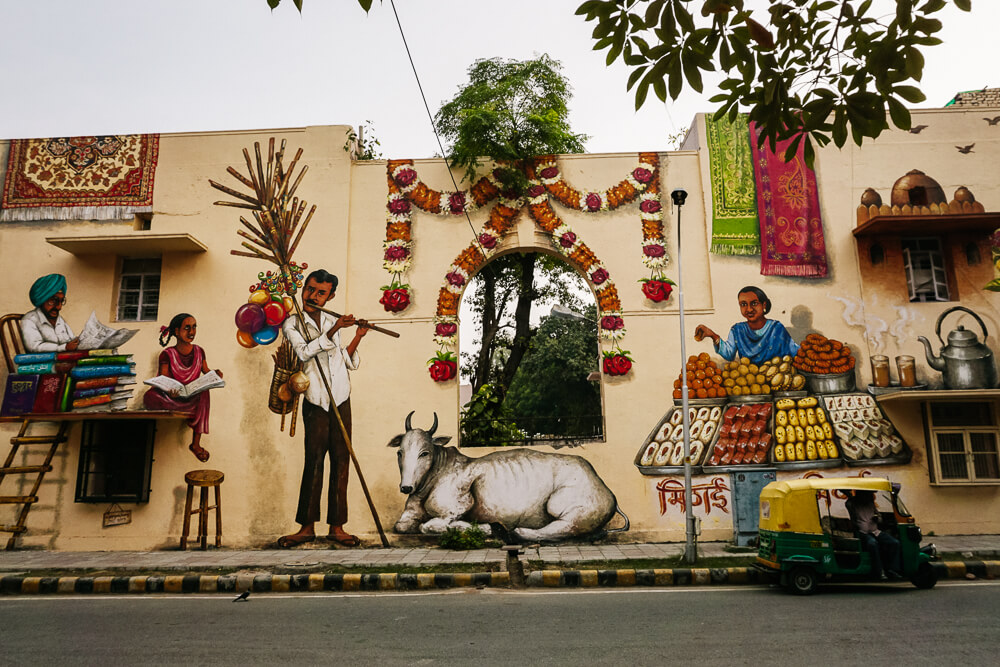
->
<box><xmin>823</xmin><ymin>393</ymin><xmax>913</xmax><ymax>467</ymax></box>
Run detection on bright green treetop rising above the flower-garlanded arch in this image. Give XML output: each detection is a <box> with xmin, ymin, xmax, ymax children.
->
<box><xmin>434</xmin><ymin>54</ymin><xmax>587</xmax><ymax>192</ymax></box>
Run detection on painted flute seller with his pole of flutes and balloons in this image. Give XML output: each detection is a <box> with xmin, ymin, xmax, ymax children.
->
<box><xmin>209</xmin><ymin>138</ymin><xmax>398</xmax><ymax>549</ymax></box>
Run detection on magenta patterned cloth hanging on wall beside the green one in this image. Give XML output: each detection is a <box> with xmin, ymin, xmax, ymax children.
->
<box><xmin>750</xmin><ymin>123</ymin><xmax>827</xmax><ymax>278</ymax></box>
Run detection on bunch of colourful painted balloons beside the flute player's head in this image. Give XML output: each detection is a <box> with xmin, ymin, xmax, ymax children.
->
<box><xmin>236</xmin><ymin>264</ymin><xmax>307</xmax><ymax>348</ymax></box>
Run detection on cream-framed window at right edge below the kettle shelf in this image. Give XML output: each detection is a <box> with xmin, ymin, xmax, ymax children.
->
<box><xmin>926</xmin><ymin>401</ymin><xmax>1000</xmax><ymax>484</ymax></box>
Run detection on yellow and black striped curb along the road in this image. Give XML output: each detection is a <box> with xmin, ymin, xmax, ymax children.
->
<box><xmin>0</xmin><ymin>560</ymin><xmax>1000</xmax><ymax>595</ymax></box>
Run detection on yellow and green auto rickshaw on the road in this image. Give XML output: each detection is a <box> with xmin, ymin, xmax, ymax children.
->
<box><xmin>754</xmin><ymin>477</ymin><xmax>937</xmax><ymax>595</ymax></box>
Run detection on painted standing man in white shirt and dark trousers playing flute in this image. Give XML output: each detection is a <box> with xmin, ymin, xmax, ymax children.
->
<box><xmin>278</xmin><ymin>269</ymin><xmax>368</xmax><ymax>549</ymax></box>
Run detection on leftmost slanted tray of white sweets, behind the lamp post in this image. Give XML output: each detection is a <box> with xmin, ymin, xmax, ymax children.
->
<box><xmin>634</xmin><ymin>405</ymin><xmax>722</xmax><ymax>475</ymax></box>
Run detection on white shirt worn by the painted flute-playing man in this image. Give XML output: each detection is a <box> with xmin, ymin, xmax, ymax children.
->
<box><xmin>281</xmin><ymin>313</ymin><xmax>361</xmax><ymax>410</ymax></box>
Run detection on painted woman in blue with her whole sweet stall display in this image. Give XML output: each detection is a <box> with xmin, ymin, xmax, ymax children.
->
<box><xmin>634</xmin><ymin>286</ymin><xmax>912</xmax><ymax>478</ymax></box>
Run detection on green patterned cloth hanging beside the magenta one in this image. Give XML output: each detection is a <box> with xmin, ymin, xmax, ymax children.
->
<box><xmin>705</xmin><ymin>114</ymin><xmax>760</xmax><ymax>255</ymax></box>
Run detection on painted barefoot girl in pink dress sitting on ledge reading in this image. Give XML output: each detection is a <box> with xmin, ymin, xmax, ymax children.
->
<box><xmin>143</xmin><ymin>313</ymin><xmax>222</xmax><ymax>463</ymax></box>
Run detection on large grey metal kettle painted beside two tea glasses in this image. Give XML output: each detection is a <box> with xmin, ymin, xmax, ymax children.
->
<box><xmin>917</xmin><ymin>306</ymin><xmax>997</xmax><ymax>389</ymax></box>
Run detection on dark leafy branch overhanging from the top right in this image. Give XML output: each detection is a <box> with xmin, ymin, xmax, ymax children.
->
<box><xmin>577</xmin><ymin>0</ymin><xmax>972</xmax><ymax>164</ymax></box>
